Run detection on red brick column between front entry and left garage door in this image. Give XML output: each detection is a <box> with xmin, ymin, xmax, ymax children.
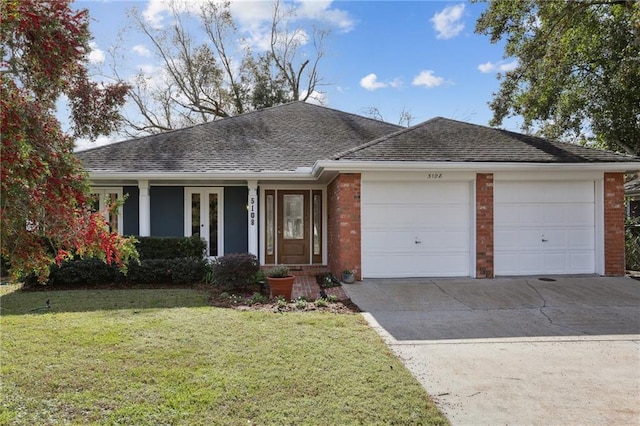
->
<box><xmin>327</xmin><ymin>173</ymin><xmax>362</xmax><ymax>279</ymax></box>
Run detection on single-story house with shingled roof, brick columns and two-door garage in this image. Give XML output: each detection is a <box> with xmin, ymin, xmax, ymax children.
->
<box><xmin>78</xmin><ymin>102</ymin><xmax>640</xmax><ymax>278</ymax></box>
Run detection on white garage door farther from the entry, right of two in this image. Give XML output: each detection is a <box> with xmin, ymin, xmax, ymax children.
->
<box><xmin>494</xmin><ymin>181</ymin><xmax>595</xmax><ymax>275</ymax></box>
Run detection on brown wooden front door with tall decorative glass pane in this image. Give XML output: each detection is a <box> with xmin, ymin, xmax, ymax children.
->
<box><xmin>277</xmin><ymin>190</ymin><xmax>310</xmax><ymax>264</ymax></box>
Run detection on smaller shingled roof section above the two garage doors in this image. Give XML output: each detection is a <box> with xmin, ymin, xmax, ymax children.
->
<box><xmin>334</xmin><ymin>117</ymin><xmax>640</xmax><ymax>163</ymax></box>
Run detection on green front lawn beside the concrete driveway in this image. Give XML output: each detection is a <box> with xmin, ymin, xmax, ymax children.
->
<box><xmin>0</xmin><ymin>286</ymin><xmax>448</xmax><ymax>425</ymax></box>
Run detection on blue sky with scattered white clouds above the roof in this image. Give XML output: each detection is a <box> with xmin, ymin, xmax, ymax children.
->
<box><xmin>72</xmin><ymin>0</ymin><xmax>521</xmax><ymax>149</ymax></box>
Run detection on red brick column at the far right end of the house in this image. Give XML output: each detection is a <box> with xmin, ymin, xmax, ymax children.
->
<box><xmin>604</xmin><ymin>173</ymin><xmax>625</xmax><ymax>276</ymax></box>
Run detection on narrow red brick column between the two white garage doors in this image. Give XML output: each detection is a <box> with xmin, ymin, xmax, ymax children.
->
<box><xmin>476</xmin><ymin>173</ymin><xmax>494</xmax><ymax>278</ymax></box>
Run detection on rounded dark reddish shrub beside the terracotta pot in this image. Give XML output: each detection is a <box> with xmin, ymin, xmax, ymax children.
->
<box><xmin>214</xmin><ymin>253</ymin><xmax>260</xmax><ymax>289</ymax></box>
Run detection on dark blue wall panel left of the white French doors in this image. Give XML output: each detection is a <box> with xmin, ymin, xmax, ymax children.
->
<box><xmin>149</xmin><ymin>186</ymin><xmax>184</xmax><ymax>237</ymax></box>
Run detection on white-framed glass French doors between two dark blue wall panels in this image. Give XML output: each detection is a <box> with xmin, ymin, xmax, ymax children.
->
<box><xmin>184</xmin><ymin>188</ymin><xmax>224</xmax><ymax>257</ymax></box>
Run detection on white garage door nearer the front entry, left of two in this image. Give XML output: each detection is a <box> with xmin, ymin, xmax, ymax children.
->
<box><xmin>362</xmin><ymin>181</ymin><xmax>471</xmax><ymax>278</ymax></box>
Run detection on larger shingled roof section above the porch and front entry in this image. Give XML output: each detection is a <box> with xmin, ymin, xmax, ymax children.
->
<box><xmin>78</xmin><ymin>102</ymin><xmax>402</xmax><ymax>173</ymax></box>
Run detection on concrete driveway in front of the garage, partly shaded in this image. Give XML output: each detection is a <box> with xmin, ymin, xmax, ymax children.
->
<box><xmin>344</xmin><ymin>276</ymin><xmax>640</xmax><ymax>425</ymax></box>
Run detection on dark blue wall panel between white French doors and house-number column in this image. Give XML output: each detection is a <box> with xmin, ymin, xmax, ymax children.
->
<box><xmin>224</xmin><ymin>186</ymin><xmax>248</xmax><ymax>254</ymax></box>
